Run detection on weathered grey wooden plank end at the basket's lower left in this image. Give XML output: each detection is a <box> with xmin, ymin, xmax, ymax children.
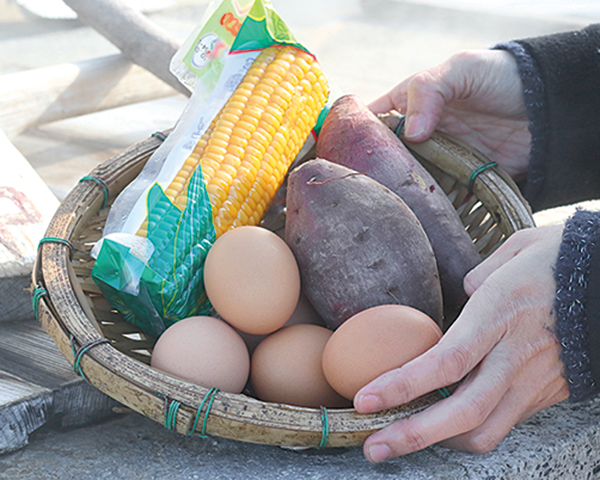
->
<box><xmin>0</xmin><ymin>320</ymin><xmax>117</xmax><ymax>454</ymax></box>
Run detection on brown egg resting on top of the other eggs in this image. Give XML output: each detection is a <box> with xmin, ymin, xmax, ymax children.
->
<box><xmin>204</xmin><ymin>226</ymin><xmax>300</xmax><ymax>335</ymax></box>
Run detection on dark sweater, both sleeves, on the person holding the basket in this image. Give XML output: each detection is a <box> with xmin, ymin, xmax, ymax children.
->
<box><xmin>495</xmin><ymin>25</ymin><xmax>600</xmax><ymax>401</ymax></box>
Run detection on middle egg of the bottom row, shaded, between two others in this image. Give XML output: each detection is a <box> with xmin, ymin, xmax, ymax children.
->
<box><xmin>250</xmin><ymin>324</ymin><xmax>350</xmax><ymax>408</ymax></box>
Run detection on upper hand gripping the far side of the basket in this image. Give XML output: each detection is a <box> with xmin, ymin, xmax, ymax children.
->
<box><xmin>369</xmin><ymin>50</ymin><xmax>531</xmax><ymax>179</ymax></box>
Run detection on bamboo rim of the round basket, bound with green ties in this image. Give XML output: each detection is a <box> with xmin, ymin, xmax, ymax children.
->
<box><xmin>32</xmin><ymin>128</ymin><xmax>533</xmax><ymax>447</ymax></box>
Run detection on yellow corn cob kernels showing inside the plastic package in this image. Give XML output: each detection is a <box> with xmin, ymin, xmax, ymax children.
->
<box><xmin>138</xmin><ymin>45</ymin><xmax>329</xmax><ymax>237</ymax></box>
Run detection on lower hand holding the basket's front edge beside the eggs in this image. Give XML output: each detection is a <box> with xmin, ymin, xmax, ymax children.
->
<box><xmin>354</xmin><ymin>226</ymin><xmax>569</xmax><ymax>462</ymax></box>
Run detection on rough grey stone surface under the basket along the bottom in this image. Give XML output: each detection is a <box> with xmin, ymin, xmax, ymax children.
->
<box><xmin>0</xmin><ymin>400</ymin><xmax>600</xmax><ymax>480</ymax></box>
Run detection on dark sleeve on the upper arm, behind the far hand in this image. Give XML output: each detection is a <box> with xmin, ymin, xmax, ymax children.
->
<box><xmin>495</xmin><ymin>25</ymin><xmax>600</xmax><ymax>211</ymax></box>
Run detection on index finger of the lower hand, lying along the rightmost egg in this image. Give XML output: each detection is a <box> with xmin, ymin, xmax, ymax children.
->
<box><xmin>354</xmin><ymin>280</ymin><xmax>505</xmax><ymax>413</ymax></box>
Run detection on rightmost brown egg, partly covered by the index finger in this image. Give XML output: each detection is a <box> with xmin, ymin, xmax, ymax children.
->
<box><xmin>323</xmin><ymin>305</ymin><xmax>442</xmax><ymax>399</ymax></box>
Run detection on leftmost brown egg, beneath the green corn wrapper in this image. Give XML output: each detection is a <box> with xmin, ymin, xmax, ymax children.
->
<box><xmin>150</xmin><ymin>316</ymin><xmax>250</xmax><ymax>393</ymax></box>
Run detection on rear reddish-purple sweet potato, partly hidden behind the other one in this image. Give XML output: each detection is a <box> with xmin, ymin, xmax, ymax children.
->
<box><xmin>317</xmin><ymin>95</ymin><xmax>481</xmax><ymax>321</ymax></box>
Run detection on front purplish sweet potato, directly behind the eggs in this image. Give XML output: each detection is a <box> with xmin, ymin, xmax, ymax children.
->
<box><xmin>285</xmin><ymin>159</ymin><xmax>442</xmax><ymax>329</ymax></box>
